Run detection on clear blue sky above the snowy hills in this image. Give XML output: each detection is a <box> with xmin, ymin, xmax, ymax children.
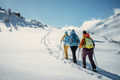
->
<box><xmin>0</xmin><ymin>0</ymin><xmax>120</xmax><ymax>27</ymax></box>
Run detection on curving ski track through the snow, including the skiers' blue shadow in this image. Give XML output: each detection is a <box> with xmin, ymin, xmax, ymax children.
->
<box><xmin>43</xmin><ymin>29</ymin><xmax>120</xmax><ymax>80</ymax></box>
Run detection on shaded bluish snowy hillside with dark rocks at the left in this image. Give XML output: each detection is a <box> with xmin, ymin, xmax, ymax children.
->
<box><xmin>0</xmin><ymin>7</ymin><xmax>47</xmax><ymax>31</ymax></box>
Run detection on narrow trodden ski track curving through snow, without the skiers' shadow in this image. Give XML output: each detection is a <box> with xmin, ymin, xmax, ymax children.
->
<box><xmin>44</xmin><ymin>29</ymin><xmax>103</xmax><ymax>79</ymax></box>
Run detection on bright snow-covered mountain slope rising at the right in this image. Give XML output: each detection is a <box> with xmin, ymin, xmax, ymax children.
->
<box><xmin>80</xmin><ymin>9</ymin><xmax>120</xmax><ymax>42</ymax></box>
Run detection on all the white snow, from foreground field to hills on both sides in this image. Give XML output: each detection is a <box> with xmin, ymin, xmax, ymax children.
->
<box><xmin>0</xmin><ymin>9</ymin><xmax>120</xmax><ymax>80</ymax></box>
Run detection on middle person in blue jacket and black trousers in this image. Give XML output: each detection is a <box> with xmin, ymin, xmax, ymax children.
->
<box><xmin>70</xmin><ymin>30</ymin><xmax>80</xmax><ymax>63</ymax></box>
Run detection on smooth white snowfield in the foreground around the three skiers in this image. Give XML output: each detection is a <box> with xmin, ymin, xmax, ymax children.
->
<box><xmin>0</xmin><ymin>27</ymin><xmax>120</xmax><ymax>80</ymax></box>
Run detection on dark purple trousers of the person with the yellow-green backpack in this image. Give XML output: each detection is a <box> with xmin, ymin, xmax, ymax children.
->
<box><xmin>82</xmin><ymin>48</ymin><xmax>96</xmax><ymax>69</ymax></box>
